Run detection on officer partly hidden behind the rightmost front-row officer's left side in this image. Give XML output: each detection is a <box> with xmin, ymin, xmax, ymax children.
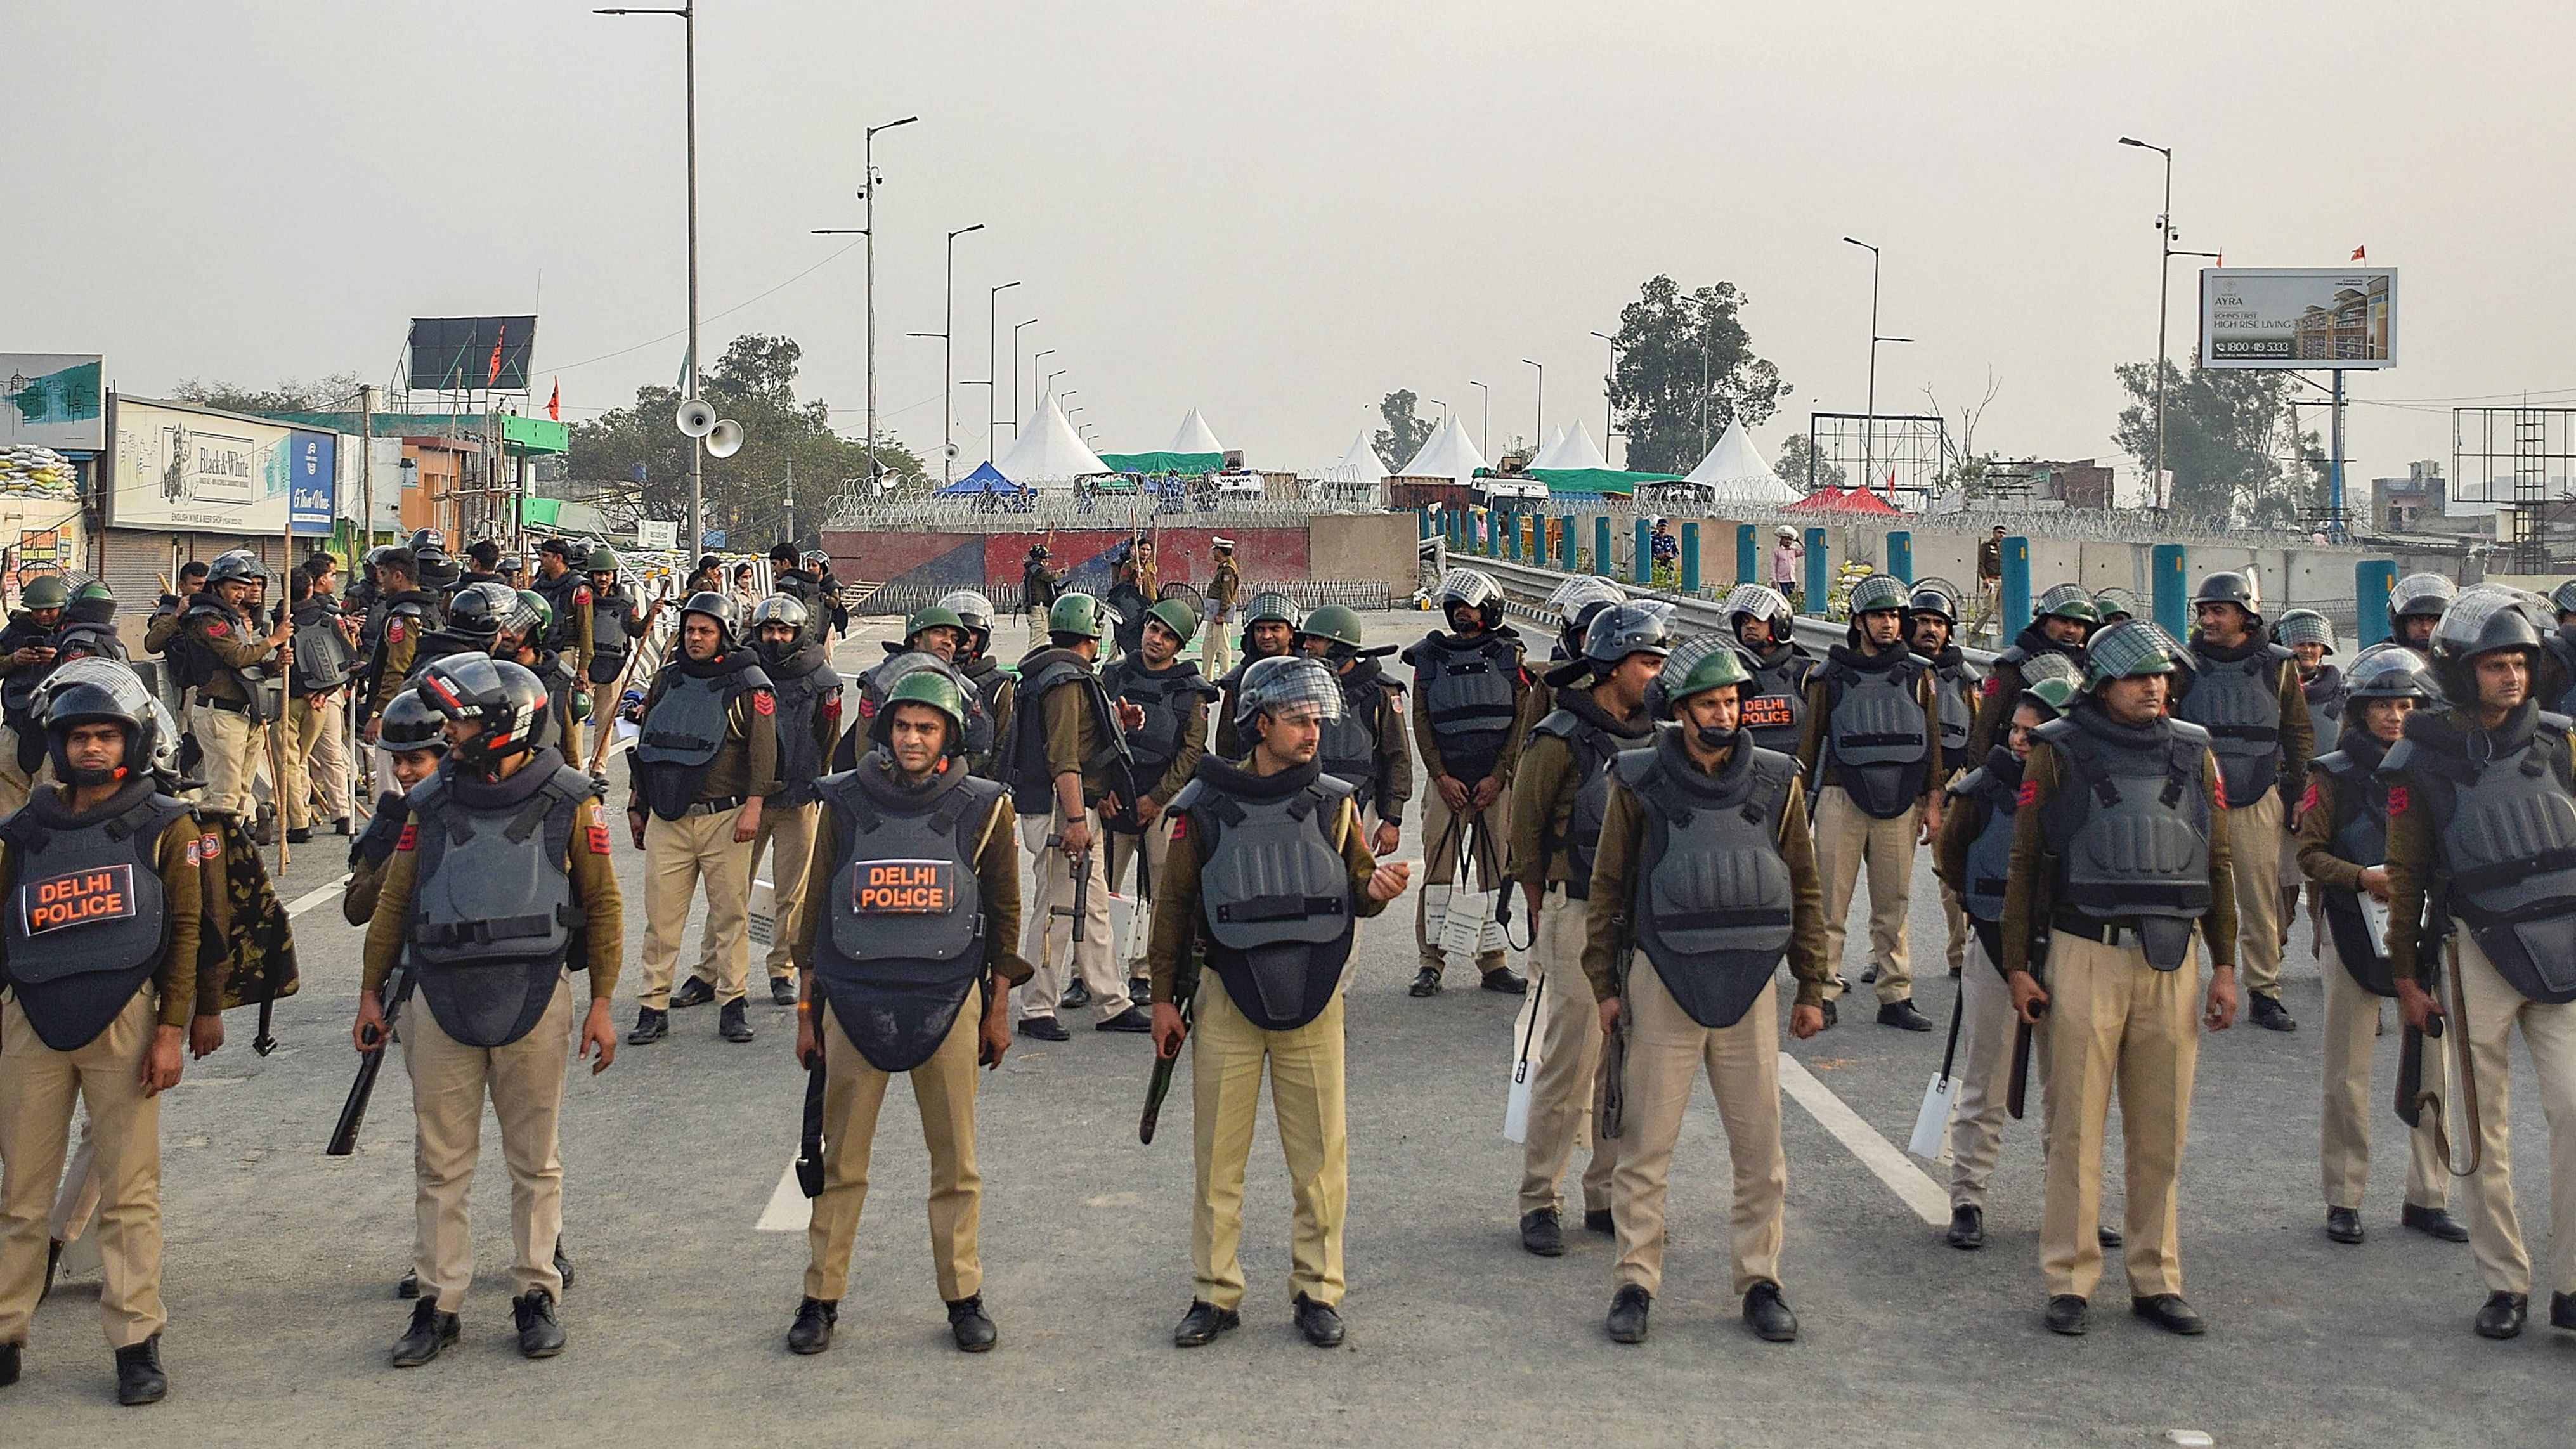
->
<box><xmin>2282</xmin><ymin>643</ymin><xmax>2468</xmax><ymax>1243</ymax></box>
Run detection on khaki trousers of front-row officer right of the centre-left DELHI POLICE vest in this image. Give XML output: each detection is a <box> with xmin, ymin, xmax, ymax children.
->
<box><xmin>1190</xmin><ymin>970</ymin><xmax>1350</xmax><ymax>1310</ymax></box>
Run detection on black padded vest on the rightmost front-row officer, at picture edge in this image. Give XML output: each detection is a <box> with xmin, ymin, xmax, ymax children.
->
<box><xmin>2380</xmin><ymin>705</ymin><xmax>2576</xmax><ymax>1006</ymax></box>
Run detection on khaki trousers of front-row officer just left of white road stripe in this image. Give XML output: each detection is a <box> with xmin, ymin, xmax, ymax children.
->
<box><xmin>1594</xmin><ymin>958</ymin><xmax>1788</xmax><ymax>1297</ymax></box>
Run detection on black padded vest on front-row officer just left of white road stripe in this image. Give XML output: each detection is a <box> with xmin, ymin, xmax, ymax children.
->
<box><xmin>1613</xmin><ymin>726</ymin><xmax>1798</xmax><ymax>1027</ymax></box>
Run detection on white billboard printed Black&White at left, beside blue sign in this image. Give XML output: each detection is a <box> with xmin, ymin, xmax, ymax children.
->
<box><xmin>108</xmin><ymin>399</ymin><xmax>296</xmax><ymax>533</ymax></box>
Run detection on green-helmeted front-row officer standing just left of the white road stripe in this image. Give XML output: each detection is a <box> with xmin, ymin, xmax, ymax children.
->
<box><xmin>1584</xmin><ymin>639</ymin><xmax>1829</xmax><ymax>1344</ymax></box>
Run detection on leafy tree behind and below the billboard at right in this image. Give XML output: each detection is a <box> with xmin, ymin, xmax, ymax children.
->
<box><xmin>2112</xmin><ymin>355</ymin><xmax>2324</xmax><ymax>528</ymax></box>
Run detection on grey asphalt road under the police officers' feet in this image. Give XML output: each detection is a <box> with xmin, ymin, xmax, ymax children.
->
<box><xmin>0</xmin><ymin>615</ymin><xmax>2576</xmax><ymax>1446</ymax></box>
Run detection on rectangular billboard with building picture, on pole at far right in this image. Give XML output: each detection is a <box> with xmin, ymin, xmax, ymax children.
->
<box><xmin>2200</xmin><ymin>268</ymin><xmax>2398</xmax><ymax>370</ymax></box>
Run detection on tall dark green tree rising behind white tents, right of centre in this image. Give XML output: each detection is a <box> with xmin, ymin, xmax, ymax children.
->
<box><xmin>1610</xmin><ymin>275</ymin><xmax>1790</xmax><ymax>474</ymax></box>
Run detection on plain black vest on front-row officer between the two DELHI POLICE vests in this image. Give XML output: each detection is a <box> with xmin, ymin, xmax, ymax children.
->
<box><xmin>410</xmin><ymin>749</ymin><xmax>597</xmax><ymax>1048</ymax></box>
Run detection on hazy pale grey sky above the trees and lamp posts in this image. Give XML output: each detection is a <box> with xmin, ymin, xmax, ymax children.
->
<box><xmin>0</xmin><ymin>0</ymin><xmax>2576</xmax><ymax>494</ymax></box>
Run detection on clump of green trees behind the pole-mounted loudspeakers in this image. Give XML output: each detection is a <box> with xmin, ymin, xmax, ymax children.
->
<box><xmin>567</xmin><ymin>335</ymin><xmax>932</xmax><ymax>548</ymax></box>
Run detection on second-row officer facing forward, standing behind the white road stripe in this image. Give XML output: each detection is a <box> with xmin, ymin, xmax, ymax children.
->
<box><xmin>1798</xmin><ymin>574</ymin><xmax>1942</xmax><ymax>1032</ymax></box>
